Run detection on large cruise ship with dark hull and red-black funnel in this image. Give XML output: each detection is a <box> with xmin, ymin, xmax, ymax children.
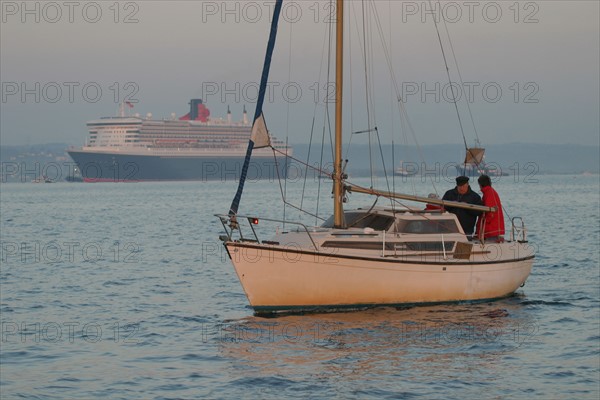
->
<box><xmin>67</xmin><ymin>99</ymin><xmax>292</xmax><ymax>182</ymax></box>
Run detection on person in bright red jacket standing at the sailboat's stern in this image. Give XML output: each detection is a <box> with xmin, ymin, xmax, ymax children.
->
<box><xmin>477</xmin><ymin>175</ymin><xmax>504</xmax><ymax>243</ymax></box>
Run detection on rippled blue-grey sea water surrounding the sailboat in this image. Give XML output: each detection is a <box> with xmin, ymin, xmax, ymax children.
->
<box><xmin>0</xmin><ymin>175</ymin><xmax>600</xmax><ymax>399</ymax></box>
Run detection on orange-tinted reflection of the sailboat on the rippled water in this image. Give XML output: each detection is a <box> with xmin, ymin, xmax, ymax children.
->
<box><xmin>217</xmin><ymin>296</ymin><xmax>538</xmax><ymax>380</ymax></box>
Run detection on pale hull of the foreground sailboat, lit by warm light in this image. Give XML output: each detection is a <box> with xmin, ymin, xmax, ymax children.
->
<box><xmin>225</xmin><ymin>242</ymin><xmax>533</xmax><ymax>312</ymax></box>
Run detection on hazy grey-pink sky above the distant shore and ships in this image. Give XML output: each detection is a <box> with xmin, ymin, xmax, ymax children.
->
<box><xmin>0</xmin><ymin>0</ymin><xmax>600</xmax><ymax>145</ymax></box>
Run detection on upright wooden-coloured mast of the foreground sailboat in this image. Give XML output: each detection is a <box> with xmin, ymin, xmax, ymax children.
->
<box><xmin>333</xmin><ymin>0</ymin><xmax>345</xmax><ymax>228</ymax></box>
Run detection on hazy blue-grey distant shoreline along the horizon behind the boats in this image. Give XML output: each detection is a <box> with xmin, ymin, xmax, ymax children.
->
<box><xmin>0</xmin><ymin>143</ymin><xmax>600</xmax><ymax>182</ymax></box>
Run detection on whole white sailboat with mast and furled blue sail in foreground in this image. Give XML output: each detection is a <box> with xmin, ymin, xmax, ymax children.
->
<box><xmin>217</xmin><ymin>0</ymin><xmax>535</xmax><ymax>314</ymax></box>
